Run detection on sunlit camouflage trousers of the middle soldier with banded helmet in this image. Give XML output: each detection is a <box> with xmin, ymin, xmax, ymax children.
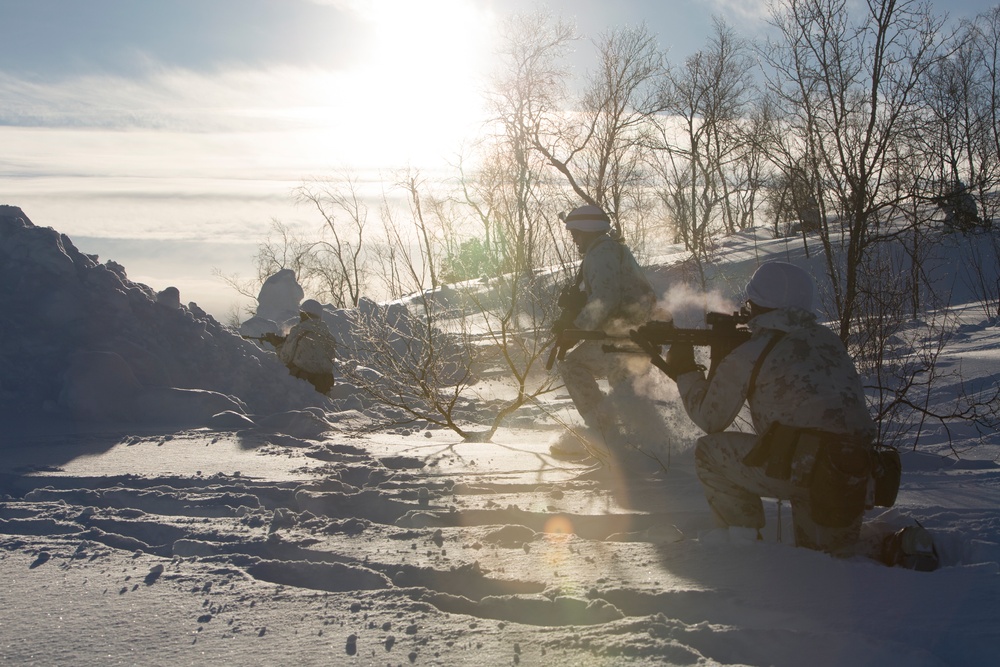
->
<box><xmin>558</xmin><ymin>341</ymin><xmax>666</xmax><ymax>444</ymax></box>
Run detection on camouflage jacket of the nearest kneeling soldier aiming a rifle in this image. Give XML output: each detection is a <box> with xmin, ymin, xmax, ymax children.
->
<box><xmin>677</xmin><ymin>308</ymin><xmax>877</xmax><ymax>440</ymax></box>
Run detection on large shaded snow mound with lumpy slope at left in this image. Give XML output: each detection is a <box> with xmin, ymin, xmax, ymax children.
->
<box><xmin>0</xmin><ymin>206</ymin><xmax>328</xmax><ymax>434</ymax></box>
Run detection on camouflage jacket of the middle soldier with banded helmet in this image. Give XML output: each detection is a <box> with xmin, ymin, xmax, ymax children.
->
<box><xmin>573</xmin><ymin>236</ymin><xmax>656</xmax><ymax>332</ymax></box>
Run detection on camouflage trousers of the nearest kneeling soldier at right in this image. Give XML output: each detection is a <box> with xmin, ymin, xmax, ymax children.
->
<box><xmin>695</xmin><ymin>431</ymin><xmax>864</xmax><ymax>554</ymax></box>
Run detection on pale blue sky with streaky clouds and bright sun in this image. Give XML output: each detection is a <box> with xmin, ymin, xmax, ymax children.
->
<box><xmin>0</xmin><ymin>0</ymin><xmax>990</xmax><ymax>316</ymax></box>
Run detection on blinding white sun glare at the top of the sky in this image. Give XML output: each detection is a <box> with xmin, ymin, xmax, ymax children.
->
<box><xmin>312</xmin><ymin>0</ymin><xmax>492</xmax><ymax>170</ymax></box>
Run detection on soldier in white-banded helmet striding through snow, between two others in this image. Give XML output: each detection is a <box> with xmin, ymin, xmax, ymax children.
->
<box><xmin>550</xmin><ymin>206</ymin><xmax>666</xmax><ymax>464</ymax></box>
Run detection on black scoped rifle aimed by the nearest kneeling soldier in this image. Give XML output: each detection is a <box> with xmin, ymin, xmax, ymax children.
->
<box><xmin>550</xmin><ymin>312</ymin><xmax>750</xmax><ymax>375</ymax></box>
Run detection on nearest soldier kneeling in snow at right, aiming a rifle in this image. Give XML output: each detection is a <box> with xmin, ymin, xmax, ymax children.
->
<box><xmin>665</xmin><ymin>262</ymin><xmax>877</xmax><ymax>555</ymax></box>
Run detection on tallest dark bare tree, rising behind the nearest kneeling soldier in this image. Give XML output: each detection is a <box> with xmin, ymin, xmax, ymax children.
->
<box><xmin>761</xmin><ymin>0</ymin><xmax>944</xmax><ymax>340</ymax></box>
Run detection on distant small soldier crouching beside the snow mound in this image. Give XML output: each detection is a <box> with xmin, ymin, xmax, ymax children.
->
<box><xmin>276</xmin><ymin>299</ymin><xmax>337</xmax><ymax>394</ymax></box>
